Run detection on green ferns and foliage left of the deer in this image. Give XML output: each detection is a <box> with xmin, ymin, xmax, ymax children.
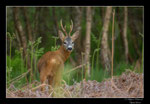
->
<box><xmin>6</xmin><ymin>37</ymin><xmax>44</xmax><ymax>87</ymax></box>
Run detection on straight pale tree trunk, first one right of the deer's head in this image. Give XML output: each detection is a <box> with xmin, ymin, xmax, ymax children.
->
<box><xmin>85</xmin><ymin>7</ymin><xmax>92</xmax><ymax>77</ymax></box>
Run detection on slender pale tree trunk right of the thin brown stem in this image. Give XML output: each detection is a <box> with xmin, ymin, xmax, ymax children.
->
<box><xmin>123</xmin><ymin>7</ymin><xmax>129</xmax><ymax>63</ymax></box>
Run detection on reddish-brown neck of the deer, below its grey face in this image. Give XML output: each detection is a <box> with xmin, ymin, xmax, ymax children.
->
<box><xmin>58</xmin><ymin>45</ymin><xmax>71</xmax><ymax>62</ymax></box>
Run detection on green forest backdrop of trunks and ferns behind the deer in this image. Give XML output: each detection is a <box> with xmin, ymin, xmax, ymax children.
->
<box><xmin>6</xmin><ymin>6</ymin><xmax>144</xmax><ymax>97</ymax></box>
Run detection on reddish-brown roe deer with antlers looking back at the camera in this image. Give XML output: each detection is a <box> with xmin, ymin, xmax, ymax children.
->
<box><xmin>37</xmin><ymin>20</ymin><xmax>79</xmax><ymax>91</ymax></box>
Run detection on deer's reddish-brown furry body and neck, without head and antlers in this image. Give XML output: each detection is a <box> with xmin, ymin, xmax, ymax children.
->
<box><xmin>38</xmin><ymin>45</ymin><xmax>71</xmax><ymax>90</ymax></box>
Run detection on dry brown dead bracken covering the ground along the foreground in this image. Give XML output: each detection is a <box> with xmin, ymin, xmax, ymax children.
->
<box><xmin>6</xmin><ymin>70</ymin><xmax>144</xmax><ymax>98</ymax></box>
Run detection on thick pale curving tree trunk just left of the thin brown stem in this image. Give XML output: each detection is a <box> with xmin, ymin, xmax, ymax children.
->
<box><xmin>101</xmin><ymin>7</ymin><xmax>112</xmax><ymax>72</ymax></box>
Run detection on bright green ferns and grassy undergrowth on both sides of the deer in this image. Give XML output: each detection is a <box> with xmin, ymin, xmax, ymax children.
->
<box><xmin>6</xmin><ymin>34</ymin><xmax>143</xmax><ymax>88</ymax></box>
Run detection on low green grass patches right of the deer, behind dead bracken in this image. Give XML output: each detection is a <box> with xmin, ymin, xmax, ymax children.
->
<box><xmin>63</xmin><ymin>62</ymin><xmax>133</xmax><ymax>85</ymax></box>
